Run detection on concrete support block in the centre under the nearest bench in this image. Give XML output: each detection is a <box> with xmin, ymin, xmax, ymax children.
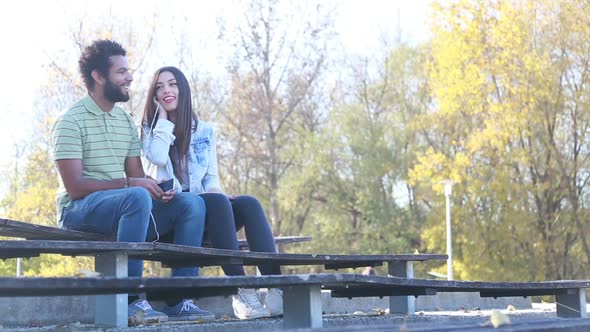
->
<box><xmin>283</xmin><ymin>285</ymin><xmax>322</xmax><ymax>329</ymax></box>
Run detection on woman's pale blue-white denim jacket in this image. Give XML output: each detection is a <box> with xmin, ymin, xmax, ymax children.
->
<box><xmin>142</xmin><ymin>119</ymin><xmax>221</xmax><ymax>193</ymax></box>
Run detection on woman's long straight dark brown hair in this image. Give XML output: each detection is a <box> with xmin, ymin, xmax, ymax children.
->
<box><xmin>141</xmin><ymin>66</ymin><xmax>198</xmax><ymax>180</ymax></box>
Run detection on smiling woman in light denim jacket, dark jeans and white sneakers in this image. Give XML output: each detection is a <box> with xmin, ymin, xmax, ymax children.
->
<box><xmin>142</xmin><ymin>67</ymin><xmax>283</xmax><ymax>319</ymax></box>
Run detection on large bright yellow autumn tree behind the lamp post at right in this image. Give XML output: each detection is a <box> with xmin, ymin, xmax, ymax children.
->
<box><xmin>410</xmin><ymin>0</ymin><xmax>590</xmax><ymax>280</ymax></box>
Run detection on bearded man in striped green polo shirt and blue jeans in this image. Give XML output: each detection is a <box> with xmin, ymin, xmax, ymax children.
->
<box><xmin>51</xmin><ymin>40</ymin><xmax>214</xmax><ymax>321</ymax></box>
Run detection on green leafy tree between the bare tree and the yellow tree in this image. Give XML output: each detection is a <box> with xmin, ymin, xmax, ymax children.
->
<box><xmin>306</xmin><ymin>44</ymin><xmax>429</xmax><ymax>270</ymax></box>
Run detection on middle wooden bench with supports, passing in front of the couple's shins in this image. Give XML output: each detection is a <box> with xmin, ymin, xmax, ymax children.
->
<box><xmin>0</xmin><ymin>240</ymin><xmax>447</xmax><ymax>327</ymax></box>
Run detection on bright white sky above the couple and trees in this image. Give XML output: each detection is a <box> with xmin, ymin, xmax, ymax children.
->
<box><xmin>0</xmin><ymin>0</ymin><xmax>430</xmax><ymax>182</ymax></box>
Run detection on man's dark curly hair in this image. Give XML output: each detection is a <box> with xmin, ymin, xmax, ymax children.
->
<box><xmin>78</xmin><ymin>39</ymin><xmax>127</xmax><ymax>91</ymax></box>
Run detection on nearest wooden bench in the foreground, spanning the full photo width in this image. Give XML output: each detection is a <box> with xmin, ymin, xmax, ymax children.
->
<box><xmin>0</xmin><ymin>274</ymin><xmax>590</xmax><ymax>328</ymax></box>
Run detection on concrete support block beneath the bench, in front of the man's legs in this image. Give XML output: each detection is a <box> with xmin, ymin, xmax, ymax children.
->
<box><xmin>94</xmin><ymin>255</ymin><xmax>127</xmax><ymax>328</ymax></box>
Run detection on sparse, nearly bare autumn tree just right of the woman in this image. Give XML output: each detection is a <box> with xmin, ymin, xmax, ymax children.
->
<box><xmin>221</xmin><ymin>0</ymin><xmax>331</xmax><ymax>234</ymax></box>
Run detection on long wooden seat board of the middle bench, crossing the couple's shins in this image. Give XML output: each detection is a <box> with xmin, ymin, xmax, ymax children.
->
<box><xmin>0</xmin><ymin>240</ymin><xmax>447</xmax><ymax>268</ymax></box>
